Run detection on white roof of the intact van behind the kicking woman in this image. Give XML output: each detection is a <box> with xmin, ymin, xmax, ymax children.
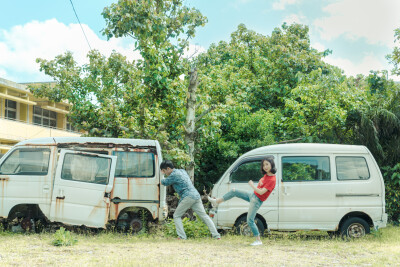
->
<box><xmin>243</xmin><ymin>143</ymin><xmax>369</xmax><ymax>156</ymax></box>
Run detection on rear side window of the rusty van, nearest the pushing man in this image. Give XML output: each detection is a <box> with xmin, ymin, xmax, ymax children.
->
<box><xmin>113</xmin><ymin>151</ymin><xmax>155</xmax><ymax>178</ymax></box>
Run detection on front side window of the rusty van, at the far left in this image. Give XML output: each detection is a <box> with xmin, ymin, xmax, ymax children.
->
<box><xmin>0</xmin><ymin>148</ymin><xmax>50</xmax><ymax>175</ymax></box>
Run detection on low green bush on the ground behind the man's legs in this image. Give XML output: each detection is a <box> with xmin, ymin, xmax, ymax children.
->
<box><xmin>165</xmin><ymin>215</ymin><xmax>210</xmax><ymax>238</ymax></box>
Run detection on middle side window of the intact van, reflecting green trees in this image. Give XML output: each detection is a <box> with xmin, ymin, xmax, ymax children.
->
<box><xmin>282</xmin><ymin>156</ymin><xmax>331</xmax><ymax>182</ymax></box>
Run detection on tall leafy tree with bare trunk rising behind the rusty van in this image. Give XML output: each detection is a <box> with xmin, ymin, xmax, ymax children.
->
<box><xmin>32</xmin><ymin>0</ymin><xmax>223</xmax><ymax>182</ymax></box>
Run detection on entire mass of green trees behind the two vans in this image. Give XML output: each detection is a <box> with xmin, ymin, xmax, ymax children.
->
<box><xmin>31</xmin><ymin>0</ymin><xmax>400</xmax><ymax>221</ymax></box>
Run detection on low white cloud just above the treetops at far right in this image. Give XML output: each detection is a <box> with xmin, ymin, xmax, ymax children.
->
<box><xmin>323</xmin><ymin>55</ymin><xmax>400</xmax><ymax>81</ymax></box>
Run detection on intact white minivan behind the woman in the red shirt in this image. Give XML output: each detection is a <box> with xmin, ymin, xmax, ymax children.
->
<box><xmin>210</xmin><ymin>143</ymin><xmax>387</xmax><ymax>237</ymax></box>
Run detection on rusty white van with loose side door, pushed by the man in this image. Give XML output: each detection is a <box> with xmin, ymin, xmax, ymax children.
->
<box><xmin>0</xmin><ymin>137</ymin><xmax>167</xmax><ymax>232</ymax></box>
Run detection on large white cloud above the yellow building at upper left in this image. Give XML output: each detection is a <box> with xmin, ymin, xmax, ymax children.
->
<box><xmin>0</xmin><ymin>19</ymin><xmax>139</xmax><ymax>82</ymax></box>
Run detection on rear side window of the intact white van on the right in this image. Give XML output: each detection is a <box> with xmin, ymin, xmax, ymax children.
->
<box><xmin>336</xmin><ymin>157</ymin><xmax>370</xmax><ymax>181</ymax></box>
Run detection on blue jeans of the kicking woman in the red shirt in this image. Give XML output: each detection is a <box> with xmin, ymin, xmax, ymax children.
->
<box><xmin>222</xmin><ymin>189</ymin><xmax>263</xmax><ymax>237</ymax></box>
